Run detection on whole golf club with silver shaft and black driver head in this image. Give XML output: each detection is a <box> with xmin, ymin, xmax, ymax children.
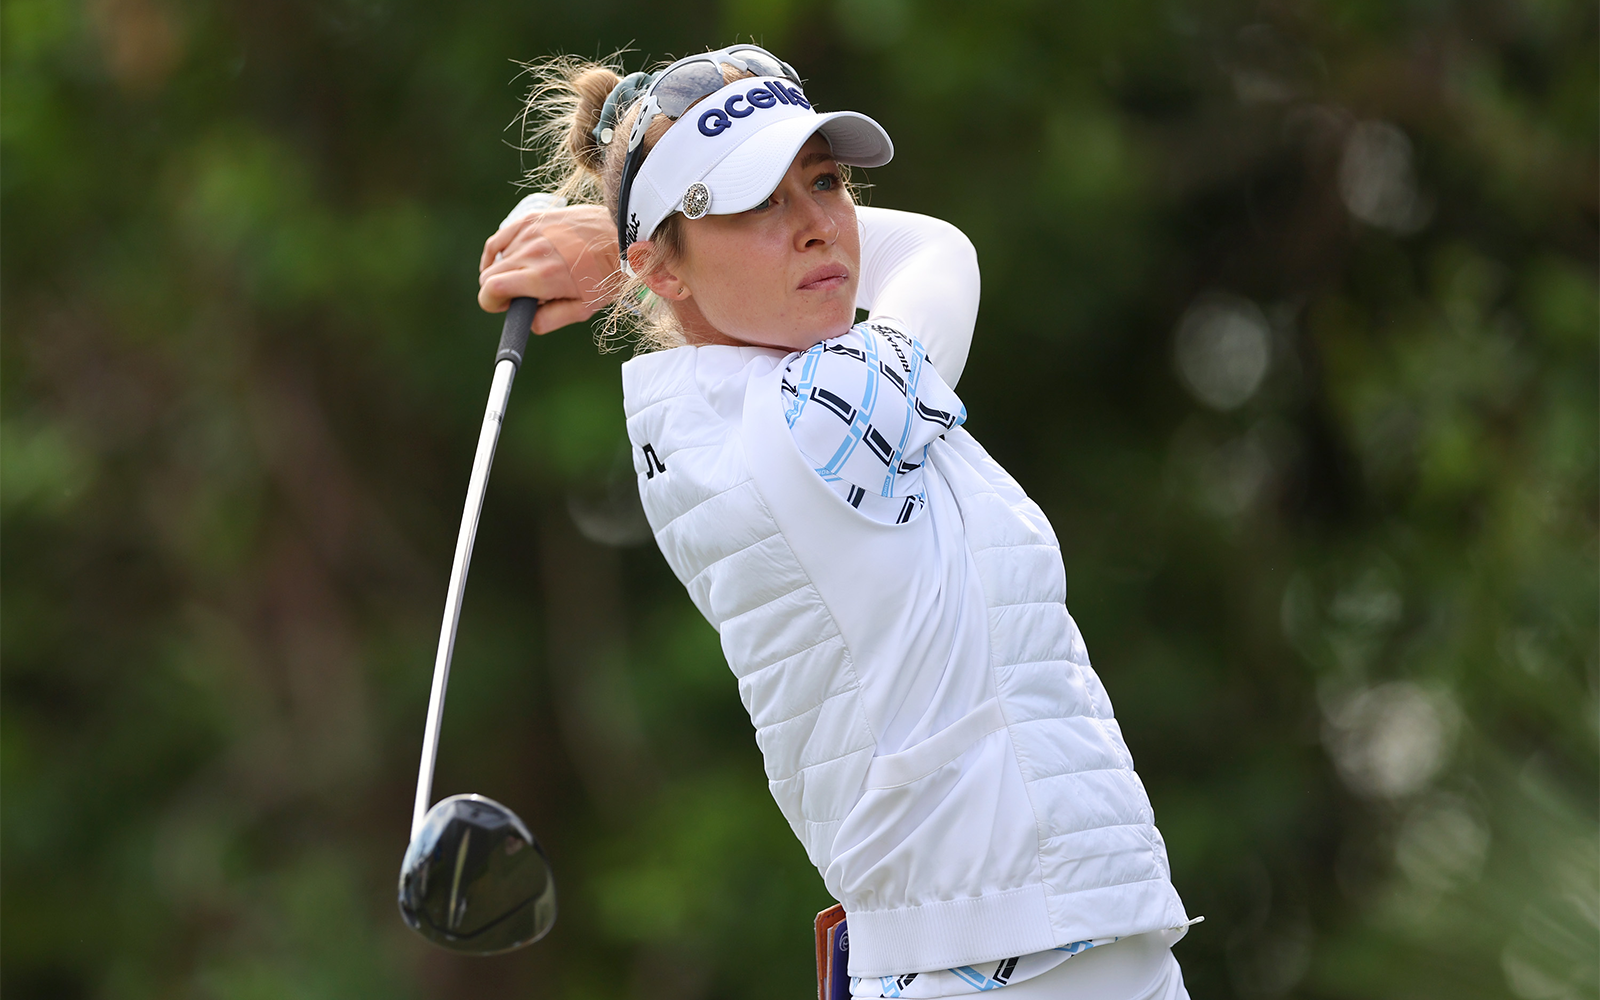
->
<box><xmin>400</xmin><ymin>194</ymin><xmax>566</xmax><ymax>955</ymax></box>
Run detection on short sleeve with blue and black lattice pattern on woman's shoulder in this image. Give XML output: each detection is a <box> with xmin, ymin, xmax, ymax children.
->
<box><xmin>782</xmin><ymin>322</ymin><xmax>966</xmax><ymax>525</ymax></box>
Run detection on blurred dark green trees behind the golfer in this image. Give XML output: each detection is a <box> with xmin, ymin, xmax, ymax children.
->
<box><xmin>0</xmin><ymin>0</ymin><xmax>1600</xmax><ymax>1000</ymax></box>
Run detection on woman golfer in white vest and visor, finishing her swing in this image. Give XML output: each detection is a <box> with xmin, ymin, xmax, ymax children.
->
<box><xmin>480</xmin><ymin>46</ymin><xmax>1189</xmax><ymax>1000</ymax></box>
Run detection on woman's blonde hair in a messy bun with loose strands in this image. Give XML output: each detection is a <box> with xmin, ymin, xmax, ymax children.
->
<box><xmin>520</xmin><ymin>53</ymin><xmax>754</xmax><ymax>350</ymax></box>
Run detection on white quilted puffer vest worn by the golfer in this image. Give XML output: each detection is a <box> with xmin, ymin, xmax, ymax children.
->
<box><xmin>622</xmin><ymin>347</ymin><xmax>1187</xmax><ymax>976</ymax></box>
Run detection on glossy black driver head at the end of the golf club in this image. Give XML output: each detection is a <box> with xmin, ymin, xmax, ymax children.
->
<box><xmin>400</xmin><ymin>795</ymin><xmax>555</xmax><ymax>955</ymax></box>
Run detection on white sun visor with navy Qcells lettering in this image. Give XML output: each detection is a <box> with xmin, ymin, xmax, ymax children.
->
<box><xmin>622</xmin><ymin>77</ymin><xmax>894</xmax><ymax>262</ymax></box>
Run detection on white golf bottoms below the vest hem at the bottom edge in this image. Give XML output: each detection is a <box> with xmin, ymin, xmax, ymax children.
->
<box><xmin>1002</xmin><ymin>931</ymin><xmax>1189</xmax><ymax>1000</ymax></box>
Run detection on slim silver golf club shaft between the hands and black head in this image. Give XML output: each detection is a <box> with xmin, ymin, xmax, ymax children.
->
<box><xmin>411</xmin><ymin>299</ymin><xmax>539</xmax><ymax>840</ymax></box>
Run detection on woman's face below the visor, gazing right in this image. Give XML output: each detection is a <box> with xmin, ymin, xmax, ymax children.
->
<box><xmin>677</xmin><ymin>136</ymin><xmax>861</xmax><ymax>350</ymax></box>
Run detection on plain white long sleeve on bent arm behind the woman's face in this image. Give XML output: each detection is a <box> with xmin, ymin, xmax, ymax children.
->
<box><xmin>856</xmin><ymin>205</ymin><xmax>979</xmax><ymax>387</ymax></box>
